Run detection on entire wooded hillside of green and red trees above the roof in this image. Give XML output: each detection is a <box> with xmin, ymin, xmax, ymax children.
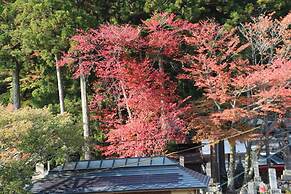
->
<box><xmin>0</xmin><ymin>0</ymin><xmax>291</xmax><ymax>193</ymax></box>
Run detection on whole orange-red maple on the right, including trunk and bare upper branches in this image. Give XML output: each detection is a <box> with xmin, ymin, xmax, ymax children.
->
<box><xmin>180</xmin><ymin>16</ymin><xmax>291</xmax><ymax>190</ymax></box>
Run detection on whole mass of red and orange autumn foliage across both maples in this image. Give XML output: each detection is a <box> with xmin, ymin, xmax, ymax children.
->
<box><xmin>60</xmin><ymin>14</ymin><xmax>291</xmax><ymax>157</ymax></box>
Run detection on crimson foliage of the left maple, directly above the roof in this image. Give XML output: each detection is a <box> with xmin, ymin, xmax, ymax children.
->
<box><xmin>63</xmin><ymin>14</ymin><xmax>194</xmax><ymax>157</ymax></box>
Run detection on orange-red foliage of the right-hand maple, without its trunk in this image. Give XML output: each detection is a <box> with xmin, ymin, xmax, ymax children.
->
<box><xmin>180</xmin><ymin>15</ymin><xmax>291</xmax><ymax>139</ymax></box>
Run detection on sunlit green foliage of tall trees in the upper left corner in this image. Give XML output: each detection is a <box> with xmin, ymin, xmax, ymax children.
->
<box><xmin>0</xmin><ymin>0</ymin><xmax>97</xmax><ymax>110</ymax></box>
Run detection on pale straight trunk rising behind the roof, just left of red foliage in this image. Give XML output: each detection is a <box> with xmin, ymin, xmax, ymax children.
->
<box><xmin>80</xmin><ymin>75</ymin><xmax>91</xmax><ymax>160</ymax></box>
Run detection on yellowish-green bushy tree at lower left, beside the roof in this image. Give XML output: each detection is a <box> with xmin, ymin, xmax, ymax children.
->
<box><xmin>0</xmin><ymin>107</ymin><xmax>83</xmax><ymax>193</ymax></box>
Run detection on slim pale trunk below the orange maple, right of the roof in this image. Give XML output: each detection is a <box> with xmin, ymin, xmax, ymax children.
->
<box><xmin>228</xmin><ymin>144</ymin><xmax>236</xmax><ymax>191</ymax></box>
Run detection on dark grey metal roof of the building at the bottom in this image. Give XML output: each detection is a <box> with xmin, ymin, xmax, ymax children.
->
<box><xmin>31</xmin><ymin>157</ymin><xmax>210</xmax><ymax>194</ymax></box>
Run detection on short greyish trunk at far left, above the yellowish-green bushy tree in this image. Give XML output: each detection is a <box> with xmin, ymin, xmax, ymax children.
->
<box><xmin>12</xmin><ymin>62</ymin><xmax>20</xmax><ymax>110</ymax></box>
